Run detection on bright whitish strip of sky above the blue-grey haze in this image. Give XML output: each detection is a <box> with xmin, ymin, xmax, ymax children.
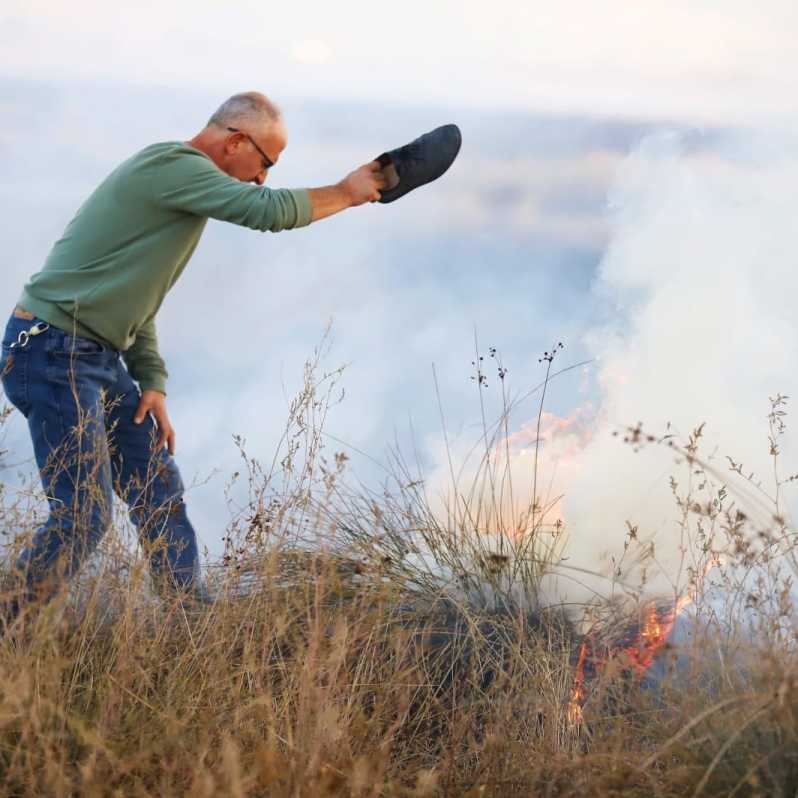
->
<box><xmin>0</xmin><ymin>0</ymin><xmax>798</xmax><ymax>121</ymax></box>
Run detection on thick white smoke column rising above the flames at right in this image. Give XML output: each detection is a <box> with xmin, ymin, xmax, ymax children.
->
<box><xmin>559</xmin><ymin>123</ymin><xmax>798</xmax><ymax>598</ymax></box>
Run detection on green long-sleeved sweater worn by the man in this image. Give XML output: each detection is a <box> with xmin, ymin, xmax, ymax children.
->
<box><xmin>19</xmin><ymin>141</ymin><xmax>312</xmax><ymax>393</ymax></box>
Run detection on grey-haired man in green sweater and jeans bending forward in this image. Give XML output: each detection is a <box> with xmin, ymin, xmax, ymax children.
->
<box><xmin>0</xmin><ymin>92</ymin><xmax>386</xmax><ymax>614</ymax></box>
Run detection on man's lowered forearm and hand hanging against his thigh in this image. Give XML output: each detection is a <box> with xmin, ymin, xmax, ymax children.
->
<box><xmin>122</xmin><ymin>319</ymin><xmax>175</xmax><ymax>454</ymax></box>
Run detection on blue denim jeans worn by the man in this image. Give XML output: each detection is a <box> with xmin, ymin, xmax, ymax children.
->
<box><xmin>0</xmin><ymin>316</ymin><xmax>200</xmax><ymax>600</ymax></box>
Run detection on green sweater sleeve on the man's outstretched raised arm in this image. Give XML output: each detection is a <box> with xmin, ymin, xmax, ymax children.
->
<box><xmin>153</xmin><ymin>146</ymin><xmax>313</xmax><ymax>233</ymax></box>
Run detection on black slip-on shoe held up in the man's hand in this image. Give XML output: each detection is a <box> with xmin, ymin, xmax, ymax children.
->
<box><xmin>376</xmin><ymin>125</ymin><xmax>463</xmax><ymax>202</ymax></box>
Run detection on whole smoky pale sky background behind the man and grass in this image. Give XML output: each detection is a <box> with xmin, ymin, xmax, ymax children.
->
<box><xmin>0</xmin><ymin>0</ymin><xmax>798</xmax><ymax>608</ymax></box>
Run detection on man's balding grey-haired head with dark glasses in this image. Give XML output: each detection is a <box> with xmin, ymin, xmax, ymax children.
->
<box><xmin>189</xmin><ymin>91</ymin><xmax>288</xmax><ymax>186</ymax></box>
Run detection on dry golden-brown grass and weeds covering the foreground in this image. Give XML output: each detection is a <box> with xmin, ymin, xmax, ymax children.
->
<box><xmin>0</xmin><ymin>340</ymin><xmax>798</xmax><ymax>797</ymax></box>
